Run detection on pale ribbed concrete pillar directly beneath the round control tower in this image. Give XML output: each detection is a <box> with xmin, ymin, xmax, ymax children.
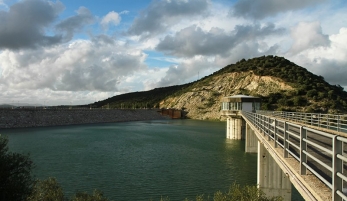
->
<box><xmin>226</xmin><ymin>117</ymin><xmax>246</xmax><ymax>140</ymax></box>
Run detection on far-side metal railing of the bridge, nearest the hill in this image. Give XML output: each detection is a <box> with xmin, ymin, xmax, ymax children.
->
<box><xmin>257</xmin><ymin>110</ymin><xmax>347</xmax><ymax>133</ymax></box>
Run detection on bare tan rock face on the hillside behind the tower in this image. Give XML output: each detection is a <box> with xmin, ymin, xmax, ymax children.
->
<box><xmin>160</xmin><ymin>71</ymin><xmax>293</xmax><ymax>120</ymax></box>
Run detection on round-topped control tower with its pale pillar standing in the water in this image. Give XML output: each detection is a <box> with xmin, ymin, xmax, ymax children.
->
<box><xmin>221</xmin><ymin>95</ymin><xmax>261</xmax><ymax>140</ymax></box>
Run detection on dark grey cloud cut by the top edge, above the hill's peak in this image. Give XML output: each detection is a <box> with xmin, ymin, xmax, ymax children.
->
<box><xmin>230</xmin><ymin>0</ymin><xmax>327</xmax><ymax>20</ymax></box>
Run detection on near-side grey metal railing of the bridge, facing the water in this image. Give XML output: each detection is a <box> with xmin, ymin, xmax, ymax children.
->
<box><xmin>242</xmin><ymin>111</ymin><xmax>347</xmax><ymax>201</ymax></box>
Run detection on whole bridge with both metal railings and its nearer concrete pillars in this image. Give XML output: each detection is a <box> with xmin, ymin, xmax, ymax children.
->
<box><xmin>241</xmin><ymin>111</ymin><xmax>347</xmax><ymax>201</ymax></box>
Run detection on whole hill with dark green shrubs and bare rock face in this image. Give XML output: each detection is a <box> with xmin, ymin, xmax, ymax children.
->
<box><xmin>94</xmin><ymin>56</ymin><xmax>347</xmax><ymax>119</ymax></box>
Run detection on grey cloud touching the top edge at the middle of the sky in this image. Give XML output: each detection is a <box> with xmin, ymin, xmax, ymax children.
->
<box><xmin>128</xmin><ymin>0</ymin><xmax>210</xmax><ymax>38</ymax></box>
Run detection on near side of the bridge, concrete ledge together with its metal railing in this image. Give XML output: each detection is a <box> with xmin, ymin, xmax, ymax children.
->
<box><xmin>242</xmin><ymin>112</ymin><xmax>347</xmax><ymax>200</ymax></box>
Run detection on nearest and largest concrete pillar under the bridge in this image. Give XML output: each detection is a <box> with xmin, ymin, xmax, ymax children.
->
<box><xmin>257</xmin><ymin>142</ymin><xmax>292</xmax><ymax>201</ymax></box>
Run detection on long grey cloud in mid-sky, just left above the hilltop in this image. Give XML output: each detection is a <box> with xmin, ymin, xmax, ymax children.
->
<box><xmin>156</xmin><ymin>24</ymin><xmax>285</xmax><ymax>57</ymax></box>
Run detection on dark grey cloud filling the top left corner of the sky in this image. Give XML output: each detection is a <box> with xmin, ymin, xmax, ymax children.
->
<box><xmin>0</xmin><ymin>0</ymin><xmax>64</xmax><ymax>49</ymax></box>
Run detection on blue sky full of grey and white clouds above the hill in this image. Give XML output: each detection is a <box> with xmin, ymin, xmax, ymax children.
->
<box><xmin>0</xmin><ymin>0</ymin><xmax>347</xmax><ymax>105</ymax></box>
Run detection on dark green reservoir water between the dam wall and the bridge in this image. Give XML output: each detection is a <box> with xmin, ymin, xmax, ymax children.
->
<box><xmin>0</xmin><ymin>120</ymin><xmax>302</xmax><ymax>201</ymax></box>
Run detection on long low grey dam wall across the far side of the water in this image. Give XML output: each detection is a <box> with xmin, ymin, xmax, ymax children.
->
<box><xmin>0</xmin><ymin>108</ymin><xmax>169</xmax><ymax>128</ymax></box>
